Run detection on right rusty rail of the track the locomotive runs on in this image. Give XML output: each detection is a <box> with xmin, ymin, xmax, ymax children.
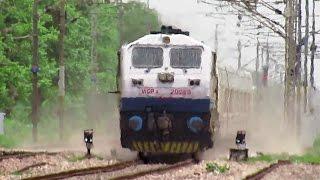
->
<box><xmin>110</xmin><ymin>160</ymin><xmax>194</xmax><ymax>180</ymax></box>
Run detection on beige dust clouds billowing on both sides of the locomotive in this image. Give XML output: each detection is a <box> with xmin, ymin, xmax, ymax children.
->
<box><xmin>16</xmin><ymin>84</ymin><xmax>320</xmax><ymax>159</ymax></box>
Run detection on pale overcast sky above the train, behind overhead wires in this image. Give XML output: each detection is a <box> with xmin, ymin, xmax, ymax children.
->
<box><xmin>136</xmin><ymin>0</ymin><xmax>320</xmax><ymax>88</ymax></box>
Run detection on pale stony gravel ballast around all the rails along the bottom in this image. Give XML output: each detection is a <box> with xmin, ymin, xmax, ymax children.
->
<box><xmin>0</xmin><ymin>148</ymin><xmax>320</xmax><ymax>180</ymax></box>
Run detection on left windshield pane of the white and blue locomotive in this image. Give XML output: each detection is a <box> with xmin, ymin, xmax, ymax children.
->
<box><xmin>132</xmin><ymin>47</ymin><xmax>163</xmax><ymax>68</ymax></box>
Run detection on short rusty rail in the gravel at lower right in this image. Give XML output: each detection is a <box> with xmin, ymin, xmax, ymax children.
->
<box><xmin>244</xmin><ymin>160</ymin><xmax>291</xmax><ymax>180</ymax></box>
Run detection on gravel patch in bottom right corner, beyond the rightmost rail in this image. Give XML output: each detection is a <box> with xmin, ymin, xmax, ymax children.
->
<box><xmin>263</xmin><ymin>164</ymin><xmax>320</xmax><ymax>180</ymax></box>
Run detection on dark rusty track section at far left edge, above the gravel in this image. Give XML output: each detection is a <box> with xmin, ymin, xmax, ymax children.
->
<box><xmin>0</xmin><ymin>151</ymin><xmax>58</xmax><ymax>162</ymax></box>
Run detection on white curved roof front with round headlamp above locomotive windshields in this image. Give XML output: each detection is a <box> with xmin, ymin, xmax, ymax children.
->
<box><xmin>123</xmin><ymin>34</ymin><xmax>211</xmax><ymax>50</ymax></box>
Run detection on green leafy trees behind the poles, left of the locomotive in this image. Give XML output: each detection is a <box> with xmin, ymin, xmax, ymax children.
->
<box><xmin>0</xmin><ymin>0</ymin><xmax>159</xmax><ymax>146</ymax></box>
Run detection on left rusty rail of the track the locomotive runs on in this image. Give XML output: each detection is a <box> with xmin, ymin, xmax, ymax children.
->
<box><xmin>24</xmin><ymin>160</ymin><xmax>140</xmax><ymax>180</ymax></box>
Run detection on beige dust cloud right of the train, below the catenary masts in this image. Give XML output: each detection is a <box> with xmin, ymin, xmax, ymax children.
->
<box><xmin>204</xmin><ymin>84</ymin><xmax>320</xmax><ymax>159</ymax></box>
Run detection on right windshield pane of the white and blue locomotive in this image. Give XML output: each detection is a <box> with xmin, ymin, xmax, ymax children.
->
<box><xmin>170</xmin><ymin>48</ymin><xmax>202</xmax><ymax>68</ymax></box>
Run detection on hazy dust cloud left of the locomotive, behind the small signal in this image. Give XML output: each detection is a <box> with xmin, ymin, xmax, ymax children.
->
<box><xmin>19</xmin><ymin>94</ymin><xmax>136</xmax><ymax>159</ymax></box>
